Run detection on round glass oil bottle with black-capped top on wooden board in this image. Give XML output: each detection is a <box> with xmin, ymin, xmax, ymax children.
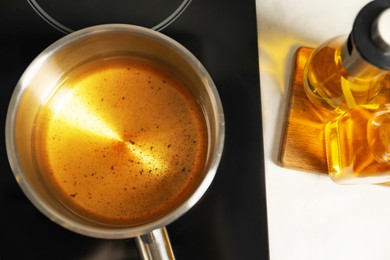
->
<box><xmin>304</xmin><ymin>0</ymin><xmax>390</xmax><ymax>114</ymax></box>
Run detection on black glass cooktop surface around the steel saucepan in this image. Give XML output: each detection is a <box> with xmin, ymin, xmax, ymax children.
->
<box><xmin>0</xmin><ymin>0</ymin><xmax>269</xmax><ymax>260</ymax></box>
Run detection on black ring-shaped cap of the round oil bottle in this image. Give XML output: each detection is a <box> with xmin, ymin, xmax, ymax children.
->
<box><xmin>350</xmin><ymin>0</ymin><xmax>390</xmax><ymax>70</ymax></box>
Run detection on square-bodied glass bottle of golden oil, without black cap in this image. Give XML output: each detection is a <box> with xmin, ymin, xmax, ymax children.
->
<box><xmin>325</xmin><ymin>104</ymin><xmax>390</xmax><ymax>184</ymax></box>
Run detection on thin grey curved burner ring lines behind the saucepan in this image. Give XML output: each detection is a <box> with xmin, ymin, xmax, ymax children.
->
<box><xmin>27</xmin><ymin>0</ymin><xmax>192</xmax><ymax>34</ymax></box>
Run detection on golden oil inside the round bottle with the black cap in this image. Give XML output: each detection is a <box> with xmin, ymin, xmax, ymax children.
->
<box><xmin>304</xmin><ymin>37</ymin><xmax>383</xmax><ymax>113</ymax></box>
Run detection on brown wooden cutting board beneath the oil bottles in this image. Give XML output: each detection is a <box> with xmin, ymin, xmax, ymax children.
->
<box><xmin>278</xmin><ymin>47</ymin><xmax>334</xmax><ymax>174</ymax></box>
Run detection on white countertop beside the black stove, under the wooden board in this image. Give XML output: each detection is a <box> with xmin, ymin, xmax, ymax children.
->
<box><xmin>256</xmin><ymin>0</ymin><xmax>390</xmax><ymax>260</ymax></box>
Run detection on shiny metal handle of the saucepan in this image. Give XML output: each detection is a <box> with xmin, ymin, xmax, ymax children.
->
<box><xmin>135</xmin><ymin>227</ymin><xmax>175</xmax><ymax>260</ymax></box>
